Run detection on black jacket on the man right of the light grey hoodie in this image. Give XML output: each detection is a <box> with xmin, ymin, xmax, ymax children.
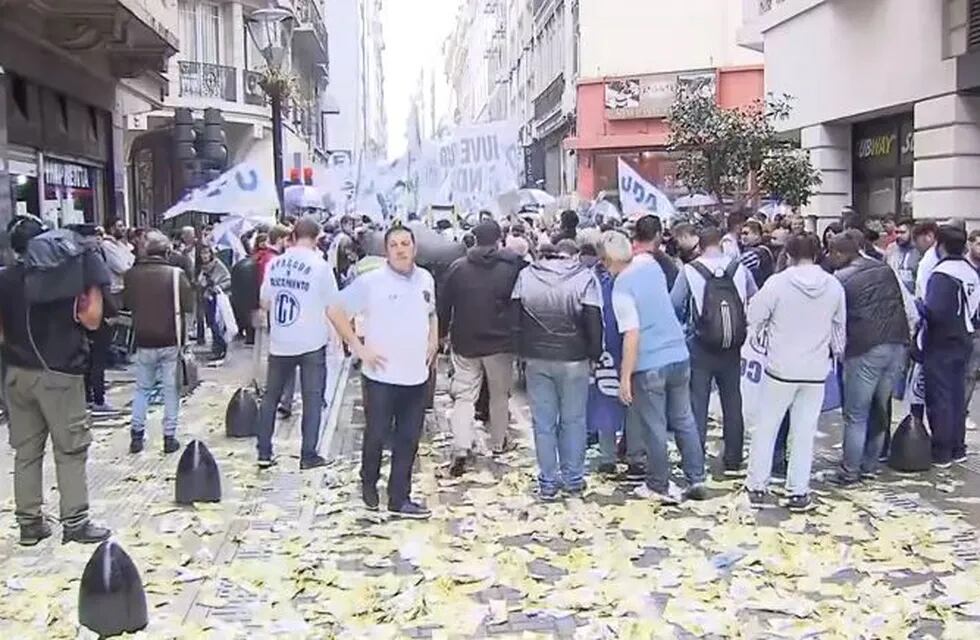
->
<box><xmin>836</xmin><ymin>257</ymin><xmax>909</xmax><ymax>358</ymax></box>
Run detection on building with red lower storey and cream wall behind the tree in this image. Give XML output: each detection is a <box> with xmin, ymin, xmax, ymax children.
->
<box><xmin>564</xmin><ymin>0</ymin><xmax>764</xmax><ymax>198</ymax></box>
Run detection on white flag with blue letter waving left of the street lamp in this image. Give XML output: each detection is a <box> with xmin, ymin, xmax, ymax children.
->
<box><xmin>163</xmin><ymin>162</ymin><xmax>279</xmax><ymax>220</ymax></box>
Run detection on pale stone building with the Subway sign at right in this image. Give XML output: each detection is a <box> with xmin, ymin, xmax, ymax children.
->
<box><xmin>740</xmin><ymin>0</ymin><xmax>980</xmax><ymax>224</ymax></box>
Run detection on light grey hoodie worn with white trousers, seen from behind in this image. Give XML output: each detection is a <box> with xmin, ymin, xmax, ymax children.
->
<box><xmin>748</xmin><ymin>264</ymin><xmax>847</xmax><ymax>384</ymax></box>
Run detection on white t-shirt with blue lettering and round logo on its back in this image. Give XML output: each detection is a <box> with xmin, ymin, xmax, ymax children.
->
<box><xmin>259</xmin><ymin>247</ymin><xmax>337</xmax><ymax>356</ymax></box>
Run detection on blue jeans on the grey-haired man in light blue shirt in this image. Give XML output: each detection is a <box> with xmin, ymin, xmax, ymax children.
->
<box><xmin>630</xmin><ymin>360</ymin><xmax>704</xmax><ymax>493</ymax></box>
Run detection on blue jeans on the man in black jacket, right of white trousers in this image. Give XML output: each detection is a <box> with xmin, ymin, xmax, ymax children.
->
<box><xmin>842</xmin><ymin>344</ymin><xmax>907</xmax><ymax>479</ymax></box>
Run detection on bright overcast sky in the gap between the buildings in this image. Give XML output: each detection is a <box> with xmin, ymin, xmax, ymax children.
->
<box><xmin>383</xmin><ymin>0</ymin><xmax>460</xmax><ymax>158</ymax></box>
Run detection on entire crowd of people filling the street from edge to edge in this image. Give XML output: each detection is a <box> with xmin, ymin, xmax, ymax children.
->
<box><xmin>0</xmin><ymin>201</ymin><xmax>980</xmax><ymax>545</ymax></box>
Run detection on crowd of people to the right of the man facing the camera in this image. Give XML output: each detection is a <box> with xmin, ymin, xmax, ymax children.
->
<box><xmin>438</xmin><ymin>210</ymin><xmax>980</xmax><ymax>511</ymax></box>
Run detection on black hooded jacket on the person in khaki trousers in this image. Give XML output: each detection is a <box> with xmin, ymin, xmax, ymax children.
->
<box><xmin>436</xmin><ymin>247</ymin><xmax>525</xmax><ymax>358</ymax></box>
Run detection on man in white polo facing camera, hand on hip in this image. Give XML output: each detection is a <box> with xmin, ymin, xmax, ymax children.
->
<box><xmin>329</xmin><ymin>226</ymin><xmax>439</xmax><ymax>519</ymax></box>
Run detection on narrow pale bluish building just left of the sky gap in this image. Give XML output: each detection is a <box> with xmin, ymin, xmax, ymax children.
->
<box><xmin>326</xmin><ymin>0</ymin><xmax>388</xmax><ymax>168</ymax></box>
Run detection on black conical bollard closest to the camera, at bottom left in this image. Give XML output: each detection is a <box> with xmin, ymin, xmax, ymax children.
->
<box><xmin>78</xmin><ymin>539</ymin><xmax>149</xmax><ymax>638</ymax></box>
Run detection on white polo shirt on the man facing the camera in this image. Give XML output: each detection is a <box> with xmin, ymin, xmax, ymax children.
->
<box><xmin>340</xmin><ymin>263</ymin><xmax>436</xmax><ymax>386</ymax></box>
